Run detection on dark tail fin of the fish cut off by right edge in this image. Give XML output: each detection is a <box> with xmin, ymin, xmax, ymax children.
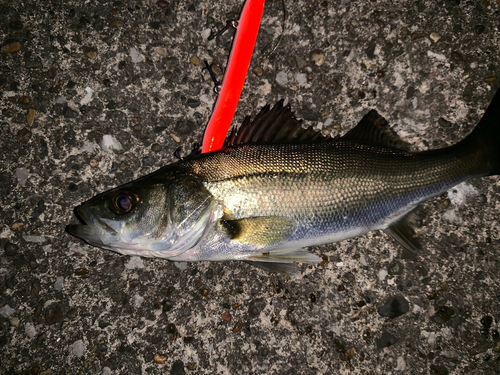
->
<box><xmin>464</xmin><ymin>89</ymin><xmax>500</xmax><ymax>176</ymax></box>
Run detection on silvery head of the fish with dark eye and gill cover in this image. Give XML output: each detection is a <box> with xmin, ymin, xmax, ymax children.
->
<box><xmin>67</xmin><ymin>178</ymin><xmax>219</xmax><ymax>259</ymax></box>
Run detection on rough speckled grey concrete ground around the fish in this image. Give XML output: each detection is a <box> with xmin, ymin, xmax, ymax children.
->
<box><xmin>0</xmin><ymin>0</ymin><xmax>500</xmax><ymax>375</ymax></box>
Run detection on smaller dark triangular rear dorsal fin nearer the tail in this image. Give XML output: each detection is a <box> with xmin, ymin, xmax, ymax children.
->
<box><xmin>340</xmin><ymin>109</ymin><xmax>409</xmax><ymax>150</ymax></box>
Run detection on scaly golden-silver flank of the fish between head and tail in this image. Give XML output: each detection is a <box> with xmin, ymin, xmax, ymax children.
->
<box><xmin>178</xmin><ymin>142</ymin><xmax>481</xmax><ymax>262</ymax></box>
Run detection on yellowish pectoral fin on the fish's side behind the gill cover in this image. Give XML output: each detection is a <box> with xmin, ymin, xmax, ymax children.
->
<box><xmin>221</xmin><ymin>216</ymin><xmax>295</xmax><ymax>245</ymax></box>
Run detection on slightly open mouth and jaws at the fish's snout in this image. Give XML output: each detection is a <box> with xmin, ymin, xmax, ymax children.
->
<box><xmin>66</xmin><ymin>206</ymin><xmax>118</xmax><ymax>247</ymax></box>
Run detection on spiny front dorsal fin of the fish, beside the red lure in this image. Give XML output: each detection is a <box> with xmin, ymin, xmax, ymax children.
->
<box><xmin>224</xmin><ymin>99</ymin><xmax>333</xmax><ymax>147</ymax></box>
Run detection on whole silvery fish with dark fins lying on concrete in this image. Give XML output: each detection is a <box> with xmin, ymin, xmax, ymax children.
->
<box><xmin>67</xmin><ymin>90</ymin><xmax>500</xmax><ymax>275</ymax></box>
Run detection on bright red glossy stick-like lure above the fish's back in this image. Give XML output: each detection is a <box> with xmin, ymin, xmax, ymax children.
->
<box><xmin>202</xmin><ymin>0</ymin><xmax>265</xmax><ymax>152</ymax></box>
